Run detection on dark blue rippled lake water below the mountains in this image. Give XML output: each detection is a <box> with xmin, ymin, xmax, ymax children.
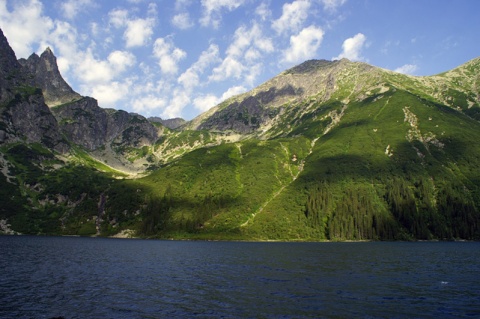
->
<box><xmin>0</xmin><ymin>236</ymin><xmax>480</xmax><ymax>319</ymax></box>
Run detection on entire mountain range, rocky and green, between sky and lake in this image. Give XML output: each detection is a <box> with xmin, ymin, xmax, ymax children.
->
<box><xmin>0</xmin><ymin>27</ymin><xmax>480</xmax><ymax>241</ymax></box>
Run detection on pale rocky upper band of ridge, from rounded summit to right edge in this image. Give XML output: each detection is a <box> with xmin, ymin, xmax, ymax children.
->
<box><xmin>186</xmin><ymin>58</ymin><xmax>480</xmax><ymax>138</ymax></box>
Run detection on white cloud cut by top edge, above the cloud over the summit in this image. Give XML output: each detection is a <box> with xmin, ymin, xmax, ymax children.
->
<box><xmin>272</xmin><ymin>0</ymin><xmax>310</xmax><ymax>34</ymax></box>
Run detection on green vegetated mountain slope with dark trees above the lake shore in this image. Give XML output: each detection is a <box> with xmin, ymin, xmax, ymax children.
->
<box><xmin>0</xmin><ymin>59</ymin><xmax>480</xmax><ymax>240</ymax></box>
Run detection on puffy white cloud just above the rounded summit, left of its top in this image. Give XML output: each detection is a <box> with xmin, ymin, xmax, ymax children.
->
<box><xmin>282</xmin><ymin>25</ymin><xmax>324</xmax><ymax>63</ymax></box>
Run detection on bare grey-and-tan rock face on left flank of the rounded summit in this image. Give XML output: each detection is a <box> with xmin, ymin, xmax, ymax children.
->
<box><xmin>188</xmin><ymin>59</ymin><xmax>366</xmax><ymax>135</ymax></box>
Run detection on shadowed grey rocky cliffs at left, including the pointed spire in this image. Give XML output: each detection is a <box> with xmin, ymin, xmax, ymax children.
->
<box><xmin>0</xmin><ymin>26</ymin><xmax>161</xmax><ymax>165</ymax></box>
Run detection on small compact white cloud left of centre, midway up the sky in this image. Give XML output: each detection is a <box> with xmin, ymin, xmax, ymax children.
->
<box><xmin>153</xmin><ymin>38</ymin><xmax>187</xmax><ymax>74</ymax></box>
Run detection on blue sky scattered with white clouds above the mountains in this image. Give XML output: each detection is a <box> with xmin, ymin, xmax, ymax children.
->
<box><xmin>0</xmin><ymin>0</ymin><xmax>480</xmax><ymax>120</ymax></box>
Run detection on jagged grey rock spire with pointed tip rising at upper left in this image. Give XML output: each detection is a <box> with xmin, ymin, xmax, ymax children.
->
<box><xmin>19</xmin><ymin>48</ymin><xmax>81</xmax><ymax>107</ymax></box>
